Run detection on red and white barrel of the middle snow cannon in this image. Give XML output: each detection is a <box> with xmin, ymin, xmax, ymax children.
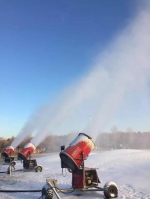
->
<box><xmin>18</xmin><ymin>142</ymin><xmax>36</xmax><ymax>160</ymax></box>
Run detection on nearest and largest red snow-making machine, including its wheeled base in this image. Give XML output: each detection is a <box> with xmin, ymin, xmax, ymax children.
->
<box><xmin>42</xmin><ymin>133</ymin><xmax>118</xmax><ymax>199</ymax></box>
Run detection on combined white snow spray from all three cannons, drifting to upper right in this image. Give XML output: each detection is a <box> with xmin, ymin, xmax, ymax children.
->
<box><xmin>12</xmin><ymin>1</ymin><xmax>150</xmax><ymax>146</ymax></box>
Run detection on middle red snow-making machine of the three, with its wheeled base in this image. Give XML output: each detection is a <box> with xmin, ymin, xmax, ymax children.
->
<box><xmin>18</xmin><ymin>142</ymin><xmax>42</xmax><ymax>172</ymax></box>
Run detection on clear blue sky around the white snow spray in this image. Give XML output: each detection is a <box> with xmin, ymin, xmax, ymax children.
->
<box><xmin>0</xmin><ymin>0</ymin><xmax>150</xmax><ymax>137</ymax></box>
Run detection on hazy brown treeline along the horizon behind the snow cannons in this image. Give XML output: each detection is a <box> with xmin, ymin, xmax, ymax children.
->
<box><xmin>0</xmin><ymin>131</ymin><xmax>150</xmax><ymax>153</ymax></box>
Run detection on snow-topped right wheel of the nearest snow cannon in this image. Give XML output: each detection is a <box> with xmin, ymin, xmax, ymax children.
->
<box><xmin>104</xmin><ymin>182</ymin><xmax>118</xmax><ymax>198</ymax></box>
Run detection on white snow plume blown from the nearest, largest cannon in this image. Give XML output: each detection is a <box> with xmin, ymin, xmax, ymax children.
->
<box><xmin>85</xmin><ymin>5</ymin><xmax>150</xmax><ymax>138</ymax></box>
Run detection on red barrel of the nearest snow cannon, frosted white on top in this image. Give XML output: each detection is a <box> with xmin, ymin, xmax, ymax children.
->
<box><xmin>59</xmin><ymin>133</ymin><xmax>94</xmax><ymax>171</ymax></box>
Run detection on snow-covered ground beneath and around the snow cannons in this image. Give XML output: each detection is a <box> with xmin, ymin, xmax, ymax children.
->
<box><xmin>0</xmin><ymin>149</ymin><xmax>150</xmax><ymax>199</ymax></box>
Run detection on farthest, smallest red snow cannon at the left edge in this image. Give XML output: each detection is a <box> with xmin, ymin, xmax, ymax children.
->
<box><xmin>1</xmin><ymin>146</ymin><xmax>14</xmax><ymax>163</ymax></box>
